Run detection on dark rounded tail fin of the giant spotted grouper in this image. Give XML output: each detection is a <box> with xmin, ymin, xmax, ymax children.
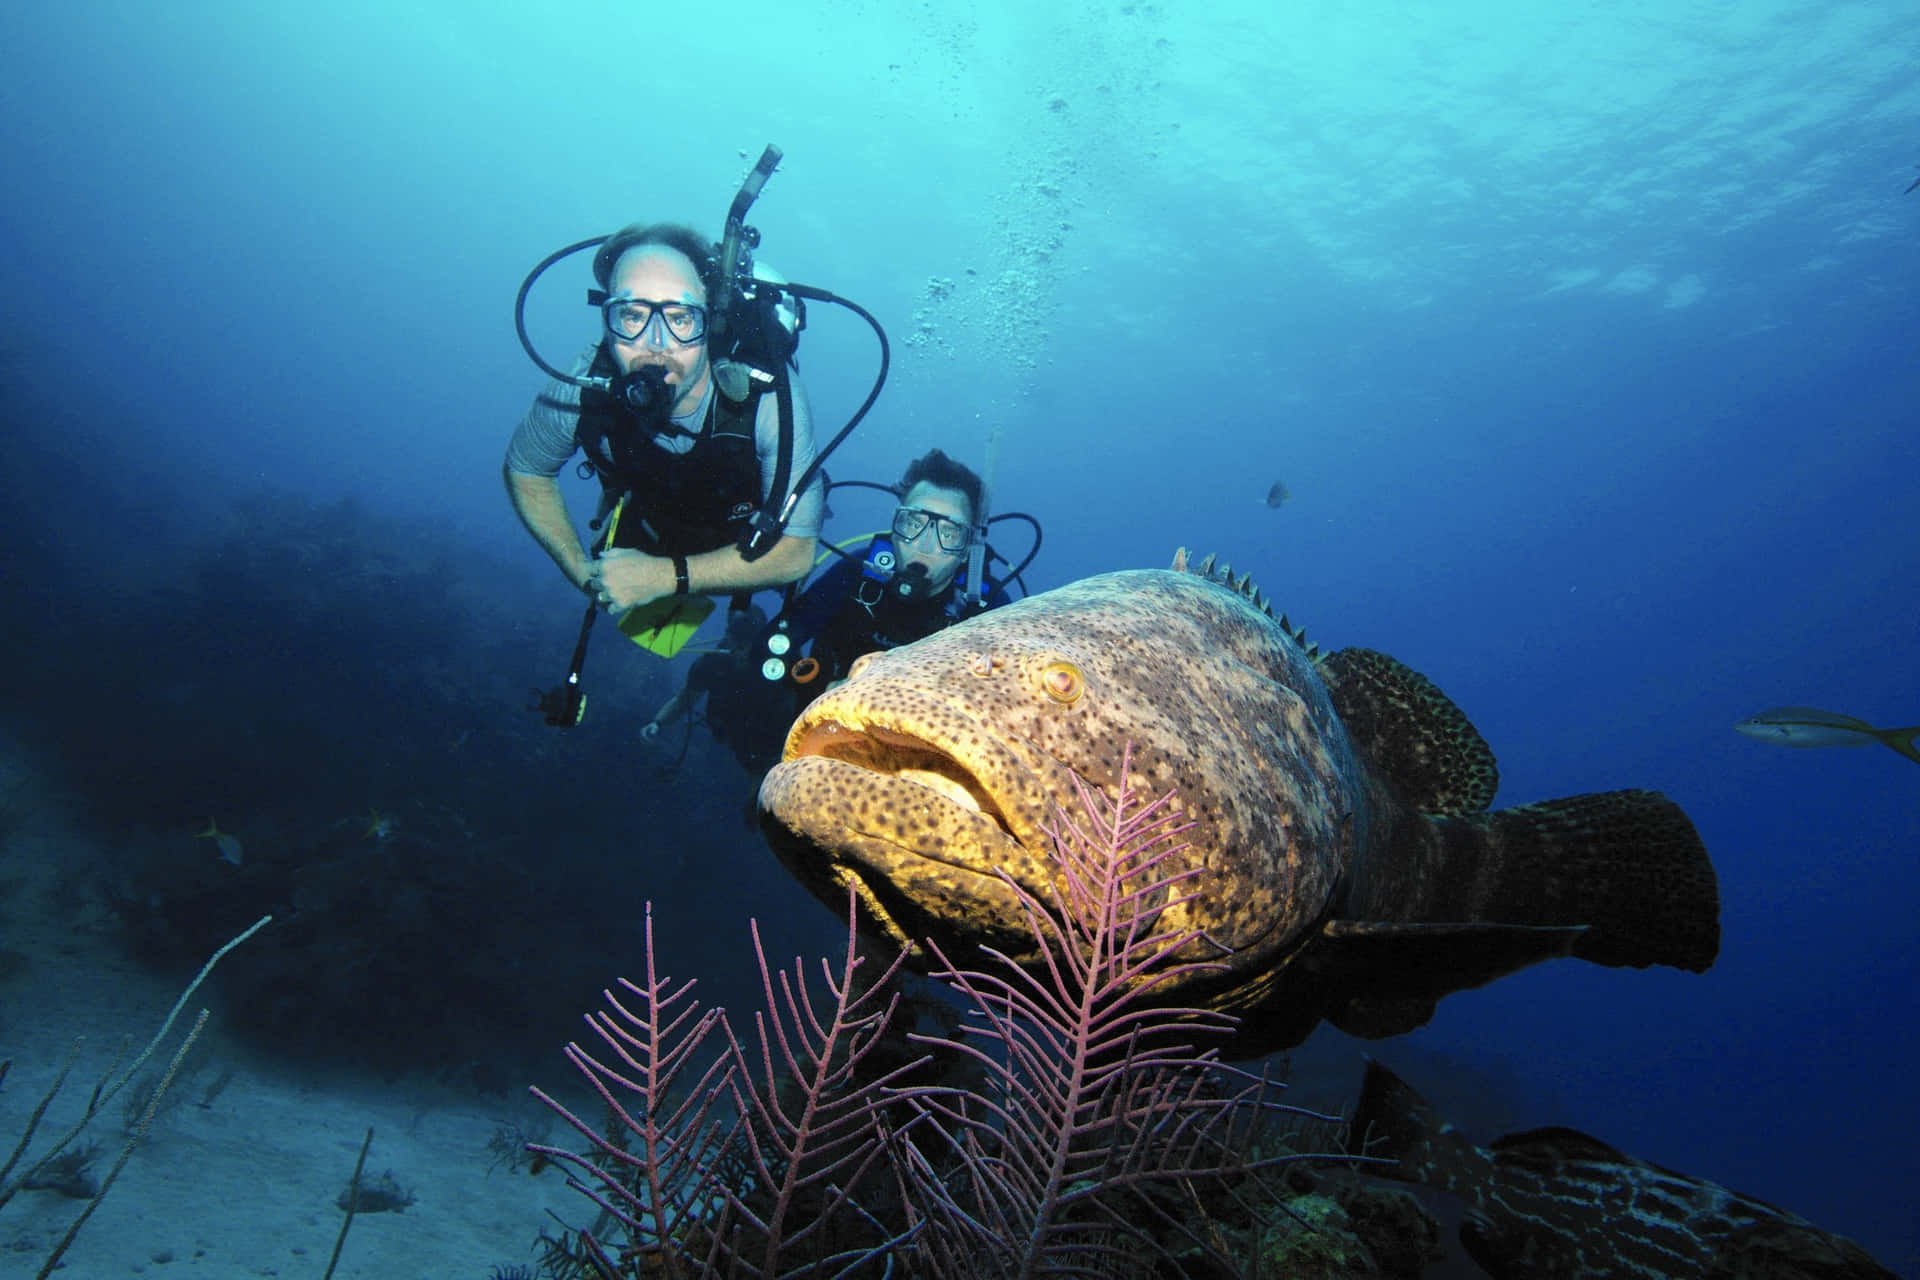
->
<box><xmin>1436</xmin><ymin>791</ymin><xmax>1720</xmax><ymax>973</ymax></box>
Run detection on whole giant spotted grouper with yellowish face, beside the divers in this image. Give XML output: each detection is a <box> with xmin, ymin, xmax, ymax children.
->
<box><xmin>760</xmin><ymin>551</ymin><xmax>1720</xmax><ymax>1055</ymax></box>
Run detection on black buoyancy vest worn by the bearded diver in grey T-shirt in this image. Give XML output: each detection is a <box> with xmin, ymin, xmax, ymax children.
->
<box><xmin>574</xmin><ymin>345</ymin><xmax>768</xmax><ymax>555</ymax></box>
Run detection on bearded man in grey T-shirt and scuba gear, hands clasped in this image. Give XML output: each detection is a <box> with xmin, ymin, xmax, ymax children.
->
<box><xmin>503</xmin><ymin>144</ymin><xmax>902</xmax><ymax>729</ymax></box>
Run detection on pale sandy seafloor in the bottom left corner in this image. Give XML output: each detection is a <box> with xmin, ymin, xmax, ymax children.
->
<box><xmin>0</xmin><ymin>756</ymin><xmax>583</xmax><ymax>1280</ymax></box>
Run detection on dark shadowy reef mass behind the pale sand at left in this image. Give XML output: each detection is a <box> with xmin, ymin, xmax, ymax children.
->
<box><xmin>0</xmin><ymin>493</ymin><xmax>706</xmax><ymax>1092</ymax></box>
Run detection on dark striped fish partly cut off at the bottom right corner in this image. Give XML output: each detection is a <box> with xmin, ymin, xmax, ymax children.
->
<box><xmin>1352</xmin><ymin>1063</ymin><xmax>1893</xmax><ymax>1280</ymax></box>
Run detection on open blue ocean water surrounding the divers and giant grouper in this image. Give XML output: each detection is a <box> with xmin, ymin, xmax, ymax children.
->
<box><xmin>0</xmin><ymin>0</ymin><xmax>1920</xmax><ymax>1274</ymax></box>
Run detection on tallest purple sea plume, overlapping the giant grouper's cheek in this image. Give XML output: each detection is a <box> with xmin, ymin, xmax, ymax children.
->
<box><xmin>899</xmin><ymin>748</ymin><xmax>1332</xmax><ymax>1276</ymax></box>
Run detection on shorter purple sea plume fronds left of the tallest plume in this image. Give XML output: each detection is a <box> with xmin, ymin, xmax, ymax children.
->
<box><xmin>530</xmin><ymin>898</ymin><xmax>925</xmax><ymax>1280</ymax></box>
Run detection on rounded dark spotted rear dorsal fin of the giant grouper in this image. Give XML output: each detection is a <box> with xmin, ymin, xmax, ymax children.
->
<box><xmin>1319</xmin><ymin>649</ymin><xmax>1500</xmax><ymax>814</ymax></box>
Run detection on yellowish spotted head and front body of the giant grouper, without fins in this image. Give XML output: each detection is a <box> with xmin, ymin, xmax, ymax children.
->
<box><xmin>760</xmin><ymin>570</ymin><xmax>1367</xmax><ymax>990</ymax></box>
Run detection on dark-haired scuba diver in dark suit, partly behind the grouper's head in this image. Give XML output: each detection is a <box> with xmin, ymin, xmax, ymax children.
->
<box><xmin>766</xmin><ymin>449</ymin><xmax>1008</xmax><ymax>714</ymax></box>
